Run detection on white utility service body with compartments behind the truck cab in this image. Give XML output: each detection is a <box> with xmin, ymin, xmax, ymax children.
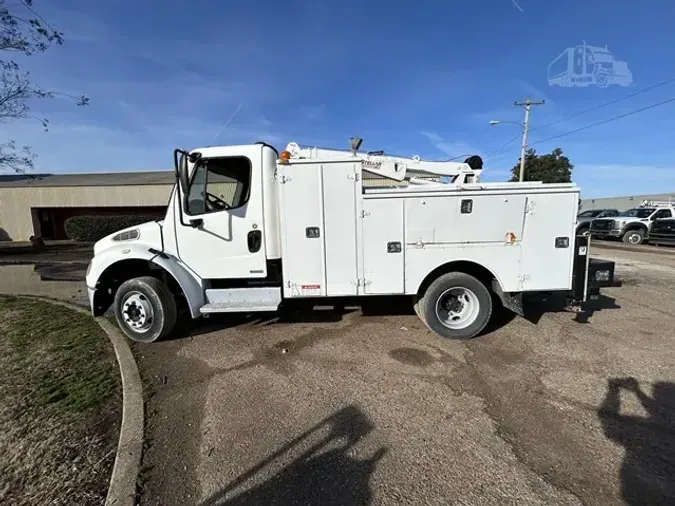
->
<box><xmin>278</xmin><ymin>158</ymin><xmax>579</xmax><ymax>297</ymax></box>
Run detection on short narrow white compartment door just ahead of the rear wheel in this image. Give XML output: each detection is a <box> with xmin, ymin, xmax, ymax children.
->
<box><xmin>362</xmin><ymin>199</ymin><xmax>405</xmax><ymax>295</ymax></box>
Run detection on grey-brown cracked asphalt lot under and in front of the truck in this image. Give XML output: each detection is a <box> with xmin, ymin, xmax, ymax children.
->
<box><xmin>129</xmin><ymin>250</ymin><xmax>675</xmax><ymax>505</ymax></box>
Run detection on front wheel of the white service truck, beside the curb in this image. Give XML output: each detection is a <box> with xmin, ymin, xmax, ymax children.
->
<box><xmin>114</xmin><ymin>276</ymin><xmax>178</xmax><ymax>343</ymax></box>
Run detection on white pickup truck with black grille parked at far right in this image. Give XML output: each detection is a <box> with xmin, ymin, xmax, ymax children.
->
<box><xmin>590</xmin><ymin>201</ymin><xmax>675</xmax><ymax>244</ymax></box>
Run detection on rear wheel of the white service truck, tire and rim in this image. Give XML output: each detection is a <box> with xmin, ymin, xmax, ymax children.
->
<box><xmin>416</xmin><ymin>272</ymin><xmax>492</xmax><ymax>339</ymax></box>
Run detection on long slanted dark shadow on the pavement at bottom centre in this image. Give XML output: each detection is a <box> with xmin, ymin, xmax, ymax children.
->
<box><xmin>198</xmin><ymin>405</ymin><xmax>387</xmax><ymax>506</ymax></box>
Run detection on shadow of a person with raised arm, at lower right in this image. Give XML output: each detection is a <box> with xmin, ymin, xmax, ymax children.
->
<box><xmin>598</xmin><ymin>378</ymin><xmax>675</xmax><ymax>505</ymax></box>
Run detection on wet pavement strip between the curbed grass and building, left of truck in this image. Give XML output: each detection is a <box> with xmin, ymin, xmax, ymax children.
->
<box><xmin>0</xmin><ymin>263</ymin><xmax>89</xmax><ymax>306</ymax></box>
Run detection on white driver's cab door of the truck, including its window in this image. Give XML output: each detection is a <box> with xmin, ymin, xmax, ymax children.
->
<box><xmin>175</xmin><ymin>146</ymin><xmax>267</xmax><ymax>279</ymax></box>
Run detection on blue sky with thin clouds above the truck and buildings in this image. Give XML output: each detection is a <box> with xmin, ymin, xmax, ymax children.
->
<box><xmin>0</xmin><ymin>0</ymin><xmax>675</xmax><ymax>197</ymax></box>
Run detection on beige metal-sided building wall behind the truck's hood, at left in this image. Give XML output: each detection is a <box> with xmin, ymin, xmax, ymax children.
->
<box><xmin>0</xmin><ymin>185</ymin><xmax>172</xmax><ymax>241</ymax></box>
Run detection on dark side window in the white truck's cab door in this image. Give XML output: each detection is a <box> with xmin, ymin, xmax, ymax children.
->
<box><xmin>187</xmin><ymin>156</ymin><xmax>251</xmax><ymax>215</ymax></box>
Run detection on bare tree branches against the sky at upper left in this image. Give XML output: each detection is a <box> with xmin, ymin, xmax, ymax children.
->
<box><xmin>0</xmin><ymin>0</ymin><xmax>89</xmax><ymax>172</ymax></box>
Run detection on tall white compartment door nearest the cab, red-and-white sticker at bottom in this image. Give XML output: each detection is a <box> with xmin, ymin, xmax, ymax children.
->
<box><xmin>279</xmin><ymin>163</ymin><xmax>326</xmax><ymax>297</ymax></box>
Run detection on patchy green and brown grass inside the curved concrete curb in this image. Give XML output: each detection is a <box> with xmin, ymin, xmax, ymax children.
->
<box><xmin>0</xmin><ymin>296</ymin><xmax>121</xmax><ymax>505</ymax></box>
